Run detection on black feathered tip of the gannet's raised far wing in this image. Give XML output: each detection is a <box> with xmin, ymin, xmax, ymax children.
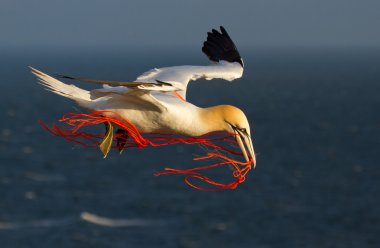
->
<box><xmin>202</xmin><ymin>26</ymin><xmax>244</xmax><ymax>67</ymax></box>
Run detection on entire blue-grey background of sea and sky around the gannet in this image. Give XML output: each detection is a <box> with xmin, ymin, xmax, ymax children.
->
<box><xmin>0</xmin><ymin>1</ymin><xmax>380</xmax><ymax>247</ymax></box>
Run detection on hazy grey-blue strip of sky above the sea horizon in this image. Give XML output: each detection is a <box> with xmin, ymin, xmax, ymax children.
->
<box><xmin>0</xmin><ymin>0</ymin><xmax>380</xmax><ymax>48</ymax></box>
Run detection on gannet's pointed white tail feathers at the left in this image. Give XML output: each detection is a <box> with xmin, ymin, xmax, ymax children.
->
<box><xmin>29</xmin><ymin>67</ymin><xmax>91</xmax><ymax>106</ymax></box>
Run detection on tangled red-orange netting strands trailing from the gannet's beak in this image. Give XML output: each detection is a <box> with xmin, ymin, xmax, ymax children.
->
<box><xmin>40</xmin><ymin>111</ymin><xmax>253</xmax><ymax>191</ymax></box>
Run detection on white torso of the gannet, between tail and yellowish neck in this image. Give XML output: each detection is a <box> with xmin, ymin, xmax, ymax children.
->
<box><xmin>90</xmin><ymin>93</ymin><xmax>207</xmax><ymax>136</ymax></box>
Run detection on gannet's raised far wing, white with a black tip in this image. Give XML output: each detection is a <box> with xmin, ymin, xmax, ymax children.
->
<box><xmin>136</xmin><ymin>26</ymin><xmax>244</xmax><ymax>98</ymax></box>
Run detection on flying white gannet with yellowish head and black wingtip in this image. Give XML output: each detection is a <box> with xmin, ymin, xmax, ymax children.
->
<box><xmin>30</xmin><ymin>26</ymin><xmax>256</xmax><ymax>167</ymax></box>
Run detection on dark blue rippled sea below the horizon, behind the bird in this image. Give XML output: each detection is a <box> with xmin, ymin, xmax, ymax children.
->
<box><xmin>0</xmin><ymin>48</ymin><xmax>380</xmax><ymax>248</ymax></box>
